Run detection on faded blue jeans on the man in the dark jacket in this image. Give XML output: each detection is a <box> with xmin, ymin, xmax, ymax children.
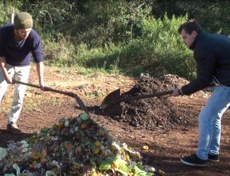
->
<box><xmin>196</xmin><ymin>85</ymin><xmax>230</xmax><ymax>160</ymax></box>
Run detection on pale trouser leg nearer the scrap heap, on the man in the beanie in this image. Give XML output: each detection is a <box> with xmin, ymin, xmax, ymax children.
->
<box><xmin>8</xmin><ymin>66</ymin><xmax>30</xmax><ymax>124</ymax></box>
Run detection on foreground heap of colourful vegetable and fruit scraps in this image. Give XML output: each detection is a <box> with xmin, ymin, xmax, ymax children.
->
<box><xmin>0</xmin><ymin>113</ymin><xmax>158</xmax><ymax>176</ymax></box>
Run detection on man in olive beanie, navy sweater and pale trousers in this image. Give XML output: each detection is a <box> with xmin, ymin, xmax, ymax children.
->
<box><xmin>0</xmin><ymin>12</ymin><xmax>45</xmax><ymax>133</ymax></box>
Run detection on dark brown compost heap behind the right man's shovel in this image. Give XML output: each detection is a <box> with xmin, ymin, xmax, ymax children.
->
<box><xmin>109</xmin><ymin>75</ymin><xmax>196</xmax><ymax>130</ymax></box>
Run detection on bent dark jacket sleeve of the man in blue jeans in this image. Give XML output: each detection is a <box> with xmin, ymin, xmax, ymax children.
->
<box><xmin>181</xmin><ymin>53</ymin><xmax>215</xmax><ymax>95</ymax></box>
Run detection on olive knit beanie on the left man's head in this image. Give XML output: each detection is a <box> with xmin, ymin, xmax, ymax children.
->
<box><xmin>14</xmin><ymin>12</ymin><xmax>33</xmax><ymax>29</ymax></box>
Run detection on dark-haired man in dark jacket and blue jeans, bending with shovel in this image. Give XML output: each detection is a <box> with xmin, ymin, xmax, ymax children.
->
<box><xmin>172</xmin><ymin>19</ymin><xmax>230</xmax><ymax>166</ymax></box>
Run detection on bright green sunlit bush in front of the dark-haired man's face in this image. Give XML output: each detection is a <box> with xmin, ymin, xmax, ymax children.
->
<box><xmin>77</xmin><ymin>16</ymin><xmax>194</xmax><ymax>78</ymax></box>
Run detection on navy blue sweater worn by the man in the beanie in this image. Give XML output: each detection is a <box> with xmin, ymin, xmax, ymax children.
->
<box><xmin>0</xmin><ymin>24</ymin><xmax>43</xmax><ymax>66</ymax></box>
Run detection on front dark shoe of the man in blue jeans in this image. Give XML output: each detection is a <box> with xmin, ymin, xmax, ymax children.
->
<box><xmin>180</xmin><ymin>154</ymin><xmax>208</xmax><ymax>167</ymax></box>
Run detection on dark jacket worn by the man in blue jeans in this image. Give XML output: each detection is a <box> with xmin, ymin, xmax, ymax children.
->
<box><xmin>181</xmin><ymin>32</ymin><xmax>230</xmax><ymax>95</ymax></box>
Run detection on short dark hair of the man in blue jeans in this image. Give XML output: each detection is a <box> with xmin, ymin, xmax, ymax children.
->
<box><xmin>178</xmin><ymin>19</ymin><xmax>203</xmax><ymax>34</ymax></box>
